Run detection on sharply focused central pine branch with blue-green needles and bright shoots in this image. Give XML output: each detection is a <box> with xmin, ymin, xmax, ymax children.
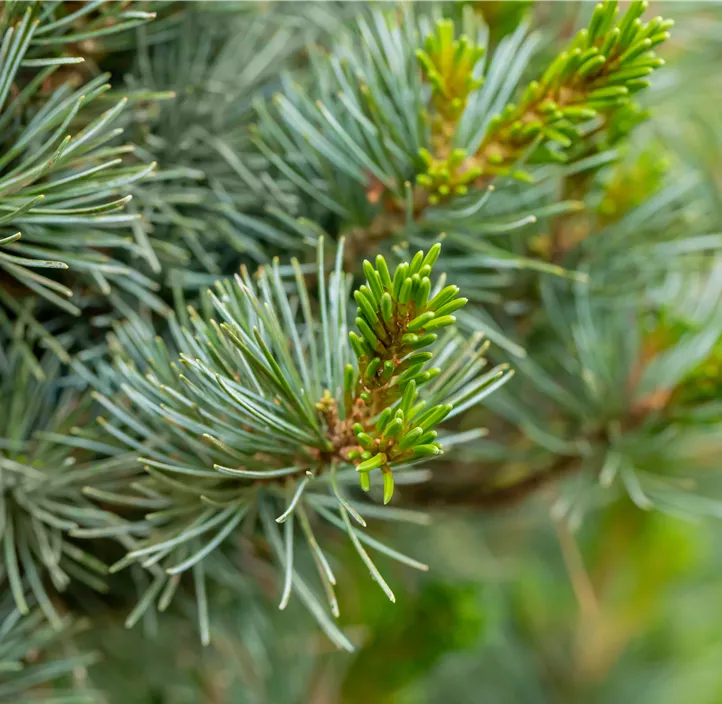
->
<box><xmin>84</xmin><ymin>240</ymin><xmax>510</xmax><ymax>648</ymax></box>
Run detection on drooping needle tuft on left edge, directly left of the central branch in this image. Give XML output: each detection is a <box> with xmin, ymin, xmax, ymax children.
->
<box><xmin>0</xmin><ymin>323</ymin><xmax>135</xmax><ymax>627</ymax></box>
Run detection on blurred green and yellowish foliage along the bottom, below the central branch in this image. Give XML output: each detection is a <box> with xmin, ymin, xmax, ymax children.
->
<box><xmin>74</xmin><ymin>499</ymin><xmax>722</xmax><ymax>704</ymax></box>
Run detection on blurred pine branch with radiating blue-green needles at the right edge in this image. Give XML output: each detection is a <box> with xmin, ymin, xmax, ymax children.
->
<box><xmin>462</xmin><ymin>272</ymin><xmax>722</xmax><ymax>515</ymax></box>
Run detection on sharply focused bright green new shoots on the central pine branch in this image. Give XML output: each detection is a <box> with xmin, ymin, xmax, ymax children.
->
<box><xmin>344</xmin><ymin>244</ymin><xmax>467</xmax><ymax>503</ymax></box>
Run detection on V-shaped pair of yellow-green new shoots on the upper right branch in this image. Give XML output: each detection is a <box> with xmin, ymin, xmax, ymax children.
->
<box><xmin>417</xmin><ymin>0</ymin><xmax>674</xmax><ymax>205</ymax></box>
